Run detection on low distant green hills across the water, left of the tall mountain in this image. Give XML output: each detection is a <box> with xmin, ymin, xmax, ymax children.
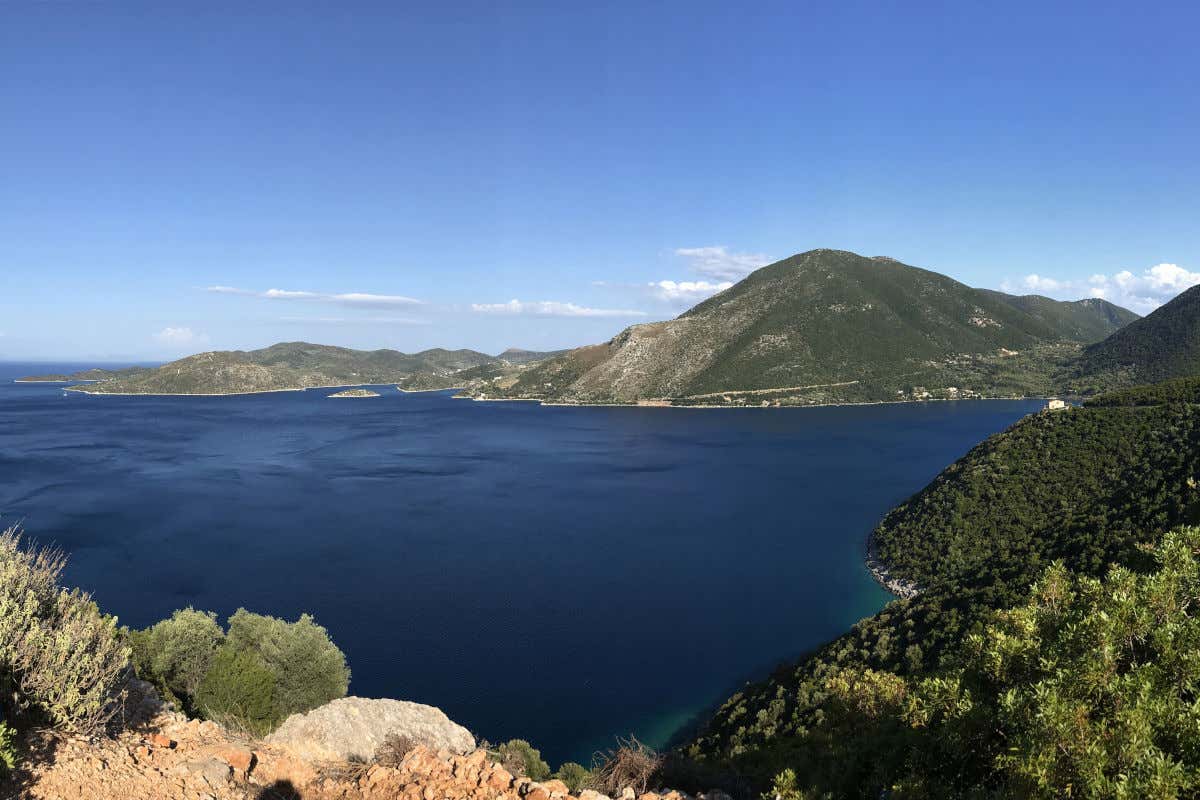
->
<box><xmin>63</xmin><ymin>342</ymin><xmax>498</xmax><ymax>395</ymax></box>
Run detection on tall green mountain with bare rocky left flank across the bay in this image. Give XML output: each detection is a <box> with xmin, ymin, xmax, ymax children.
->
<box><xmin>474</xmin><ymin>249</ymin><xmax>1136</xmax><ymax>405</ymax></box>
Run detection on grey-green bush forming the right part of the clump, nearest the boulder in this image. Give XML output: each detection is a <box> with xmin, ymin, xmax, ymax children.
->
<box><xmin>228</xmin><ymin>608</ymin><xmax>350</xmax><ymax>721</ymax></box>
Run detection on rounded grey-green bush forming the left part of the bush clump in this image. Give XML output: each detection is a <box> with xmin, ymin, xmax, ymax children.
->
<box><xmin>130</xmin><ymin>607</ymin><xmax>224</xmax><ymax>697</ymax></box>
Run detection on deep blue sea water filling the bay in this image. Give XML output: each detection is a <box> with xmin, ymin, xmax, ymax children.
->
<box><xmin>0</xmin><ymin>363</ymin><xmax>1040</xmax><ymax>765</ymax></box>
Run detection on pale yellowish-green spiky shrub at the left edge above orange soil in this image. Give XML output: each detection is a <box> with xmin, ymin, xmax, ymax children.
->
<box><xmin>0</xmin><ymin>528</ymin><xmax>130</xmax><ymax>733</ymax></box>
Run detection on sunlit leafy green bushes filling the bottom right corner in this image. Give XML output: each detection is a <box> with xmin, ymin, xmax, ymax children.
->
<box><xmin>779</xmin><ymin>528</ymin><xmax>1200</xmax><ymax>799</ymax></box>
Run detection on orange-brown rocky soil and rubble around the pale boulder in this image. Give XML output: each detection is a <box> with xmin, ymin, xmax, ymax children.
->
<box><xmin>0</xmin><ymin>693</ymin><xmax>728</xmax><ymax>800</ymax></box>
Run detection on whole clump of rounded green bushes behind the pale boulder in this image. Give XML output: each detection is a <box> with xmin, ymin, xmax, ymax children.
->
<box><xmin>128</xmin><ymin>608</ymin><xmax>350</xmax><ymax>735</ymax></box>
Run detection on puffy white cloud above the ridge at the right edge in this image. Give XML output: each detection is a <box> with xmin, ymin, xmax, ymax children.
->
<box><xmin>1001</xmin><ymin>264</ymin><xmax>1200</xmax><ymax>314</ymax></box>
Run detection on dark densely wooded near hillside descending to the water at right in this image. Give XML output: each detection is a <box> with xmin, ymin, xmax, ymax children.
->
<box><xmin>685</xmin><ymin>379</ymin><xmax>1200</xmax><ymax>796</ymax></box>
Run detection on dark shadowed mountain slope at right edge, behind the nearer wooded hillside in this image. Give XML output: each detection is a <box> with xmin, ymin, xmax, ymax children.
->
<box><xmin>1070</xmin><ymin>287</ymin><xmax>1200</xmax><ymax>387</ymax></box>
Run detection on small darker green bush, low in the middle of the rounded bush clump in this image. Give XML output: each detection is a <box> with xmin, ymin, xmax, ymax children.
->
<box><xmin>194</xmin><ymin>644</ymin><xmax>282</xmax><ymax>736</ymax></box>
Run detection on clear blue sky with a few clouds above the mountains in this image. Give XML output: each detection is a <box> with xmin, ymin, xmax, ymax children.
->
<box><xmin>0</xmin><ymin>1</ymin><xmax>1200</xmax><ymax>360</ymax></box>
